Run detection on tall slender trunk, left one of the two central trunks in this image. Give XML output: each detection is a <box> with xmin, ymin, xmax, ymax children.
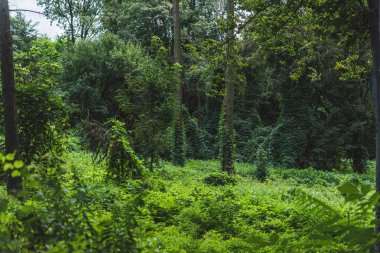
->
<box><xmin>173</xmin><ymin>0</ymin><xmax>186</xmax><ymax>166</ymax></box>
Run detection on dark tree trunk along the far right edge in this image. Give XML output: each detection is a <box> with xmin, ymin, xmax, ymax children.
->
<box><xmin>368</xmin><ymin>0</ymin><xmax>380</xmax><ymax>236</ymax></box>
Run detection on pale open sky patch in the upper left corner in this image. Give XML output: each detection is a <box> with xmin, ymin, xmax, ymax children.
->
<box><xmin>9</xmin><ymin>0</ymin><xmax>62</xmax><ymax>38</ymax></box>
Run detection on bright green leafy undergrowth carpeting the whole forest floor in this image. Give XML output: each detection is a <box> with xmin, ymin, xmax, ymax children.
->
<box><xmin>0</xmin><ymin>147</ymin><xmax>377</xmax><ymax>252</ymax></box>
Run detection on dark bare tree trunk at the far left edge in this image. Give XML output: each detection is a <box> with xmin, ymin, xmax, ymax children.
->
<box><xmin>0</xmin><ymin>0</ymin><xmax>22</xmax><ymax>195</ymax></box>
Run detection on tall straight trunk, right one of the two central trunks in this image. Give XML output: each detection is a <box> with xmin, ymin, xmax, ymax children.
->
<box><xmin>222</xmin><ymin>0</ymin><xmax>235</xmax><ymax>174</ymax></box>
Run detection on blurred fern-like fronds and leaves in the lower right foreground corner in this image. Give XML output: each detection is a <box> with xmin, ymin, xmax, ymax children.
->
<box><xmin>290</xmin><ymin>182</ymin><xmax>380</xmax><ymax>252</ymax></box>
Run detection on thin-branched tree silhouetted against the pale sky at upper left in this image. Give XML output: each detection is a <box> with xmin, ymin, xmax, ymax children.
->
<box><xmin>38</xmin><ymin>0</ymin><xmax>102</xmax><ymax>43</ymax></box>
